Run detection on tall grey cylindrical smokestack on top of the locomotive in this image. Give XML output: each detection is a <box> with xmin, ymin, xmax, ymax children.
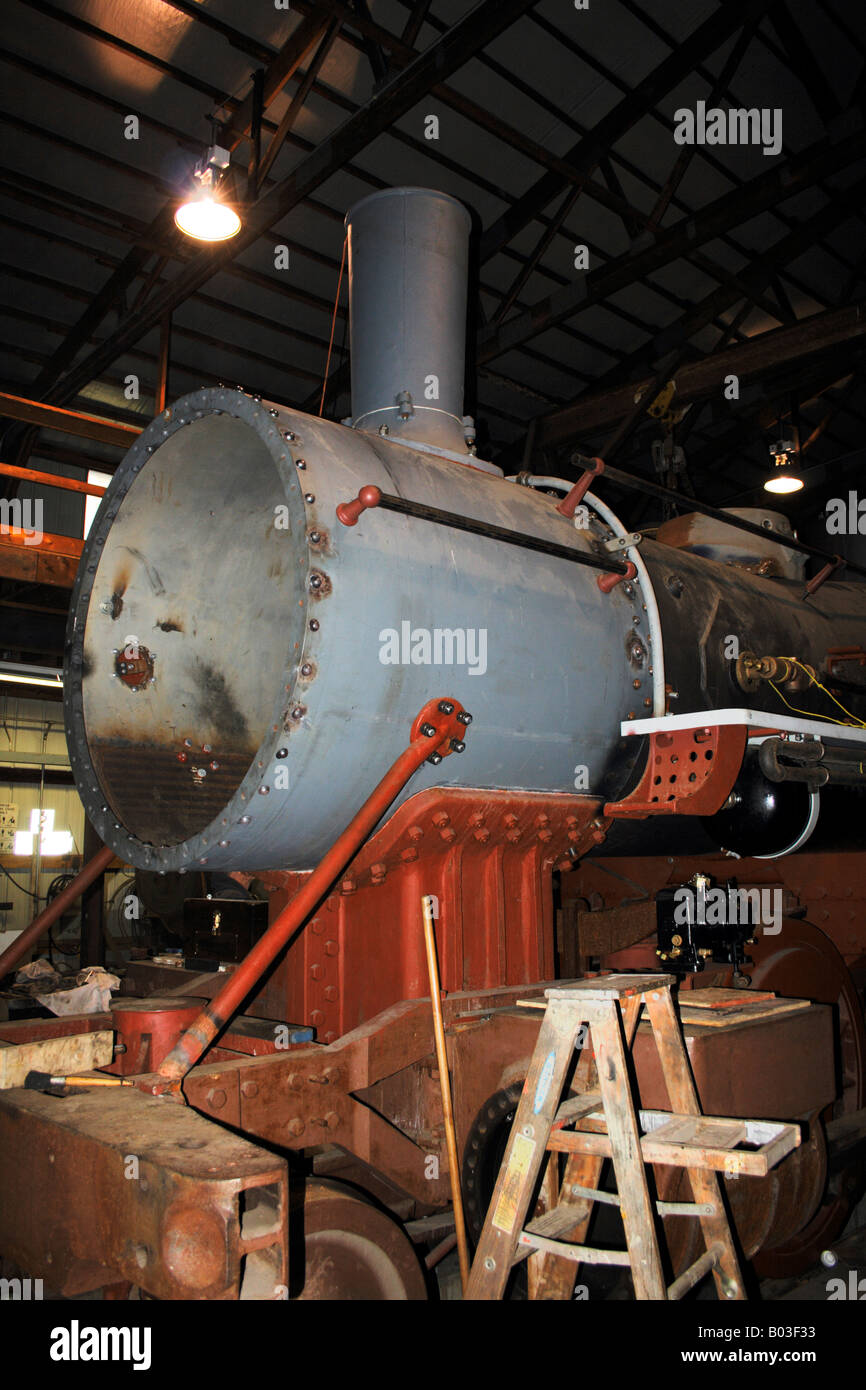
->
<box><xmin>346</xmin><ymin>188</ymin><xmax>474</xmax><ymax>455</ymax></box>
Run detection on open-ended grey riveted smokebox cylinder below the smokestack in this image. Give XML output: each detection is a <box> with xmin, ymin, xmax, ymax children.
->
<box><xmin>65</xmin><ymin>389</ymin><xmax>652</xmax><ymax>870</ymax></box>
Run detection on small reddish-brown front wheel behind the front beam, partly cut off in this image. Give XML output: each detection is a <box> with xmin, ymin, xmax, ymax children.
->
<box><xmin>289</xmin><ymin>1179</ymin><xmax>427</xmax><ymax>1302</ymax></box>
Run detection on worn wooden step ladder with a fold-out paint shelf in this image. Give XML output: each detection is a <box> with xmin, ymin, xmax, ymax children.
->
<box><xmin>466</xmin><ymin>974</ymin><xmax>801</xmax><ymax>1300</ymax></box>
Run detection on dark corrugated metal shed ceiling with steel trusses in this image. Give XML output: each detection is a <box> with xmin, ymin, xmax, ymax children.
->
<box><xmin>0</xmin><ymin>0</ymin><xmax>866</xmax><ymax>659</ymax></box>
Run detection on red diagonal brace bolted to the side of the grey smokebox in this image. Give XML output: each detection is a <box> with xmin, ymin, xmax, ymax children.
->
<box><xmin>158</xmin><ymin>699</ymin><xmax>471</xmax><ymax>1083</ymax></box>
